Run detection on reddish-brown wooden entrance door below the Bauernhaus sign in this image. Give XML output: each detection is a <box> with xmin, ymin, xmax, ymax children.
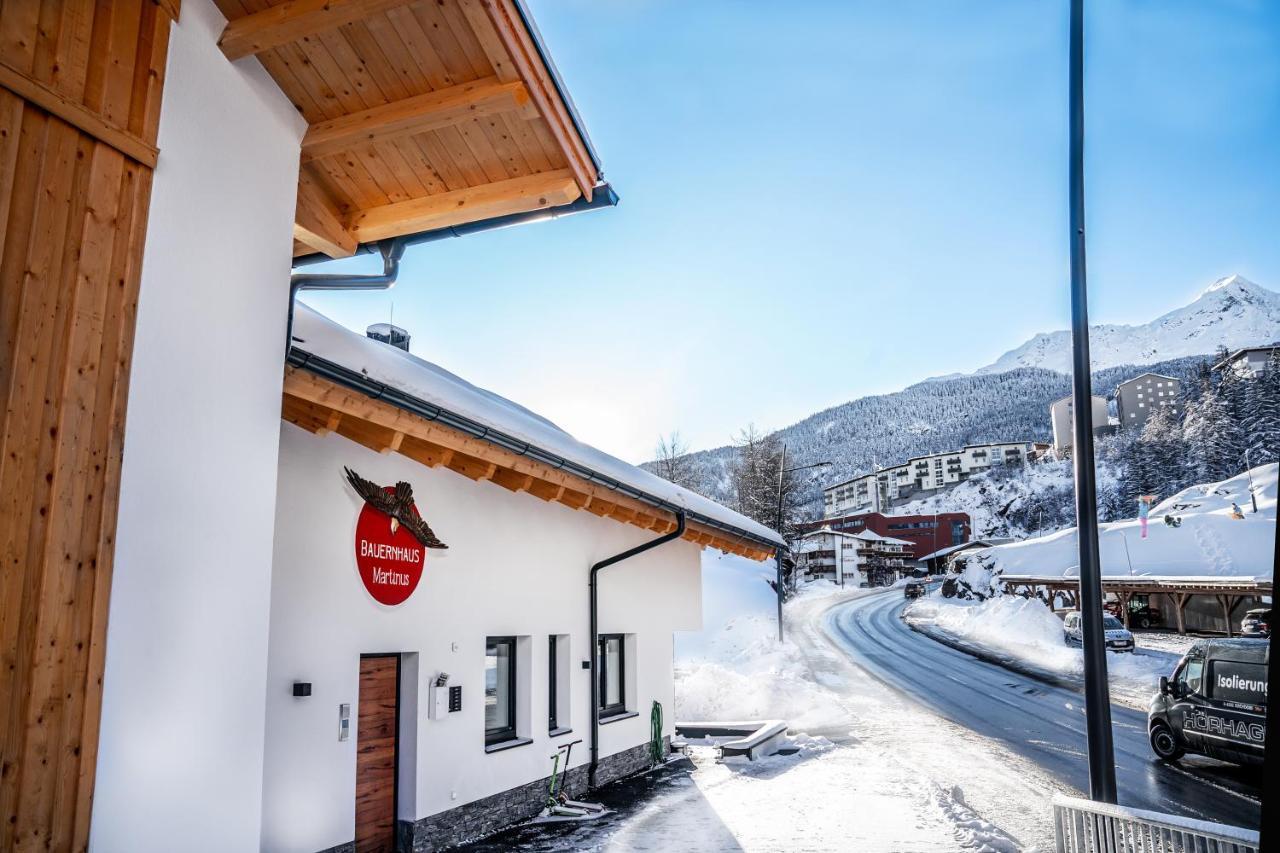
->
<box><xmin>356</xmin><ymin>654</ymin><xmax>399</xmax><ymax>853</ymax></box>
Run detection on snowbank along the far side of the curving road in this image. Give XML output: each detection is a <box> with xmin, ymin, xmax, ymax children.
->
<box><xmin>904</xmin><ymin>592</ymin><xmax>1180</xmax><ymax>710</ymax></box>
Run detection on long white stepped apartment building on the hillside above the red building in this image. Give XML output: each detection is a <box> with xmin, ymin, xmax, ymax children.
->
<box><xmin>822</xmin><ymin>442</ymin><xmax>1037</xmax><ymax>519</ymax></box>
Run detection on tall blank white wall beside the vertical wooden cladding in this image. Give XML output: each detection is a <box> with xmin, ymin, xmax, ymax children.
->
<box><xmin>91</xmin><ymin>0</ymin><xmax>305</xmax><ymax>853</ymax></box>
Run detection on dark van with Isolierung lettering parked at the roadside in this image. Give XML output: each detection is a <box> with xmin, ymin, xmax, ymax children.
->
<box><xmin>1147</xmin><ymin>639</ymin><xmax>1271</xmax><ymax>765</ymax></box>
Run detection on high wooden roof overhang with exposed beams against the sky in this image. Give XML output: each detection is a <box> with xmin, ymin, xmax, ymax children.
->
<box><xmin>215</xmin><ymin>0</ymin><xmax>602</xmax><ymax>257</ymax></box>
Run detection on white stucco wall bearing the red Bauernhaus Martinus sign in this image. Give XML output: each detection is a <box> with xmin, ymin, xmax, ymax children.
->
<box><xmin>262</xmin><ymin>424</ymin><xmax>701</xmax><ymax>853</ymax></box>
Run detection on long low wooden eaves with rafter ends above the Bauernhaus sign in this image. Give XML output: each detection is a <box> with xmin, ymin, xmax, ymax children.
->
<box><xmin>282</xmin><ymin>347</ymin><xmax>774</xmax><ymax>561</ymax></box>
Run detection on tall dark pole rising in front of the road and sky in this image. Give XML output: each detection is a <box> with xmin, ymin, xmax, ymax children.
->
<box><xmin>1068</xmin><ymin>0</ymin><xmax>1116</xmax><ymax>803</ymax></box>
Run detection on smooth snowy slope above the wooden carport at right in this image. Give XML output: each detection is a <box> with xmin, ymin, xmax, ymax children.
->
<box><xmin>974</xmin><ymin>462</ymin><xmax>1277</xmax><ymax>579</ymax></box>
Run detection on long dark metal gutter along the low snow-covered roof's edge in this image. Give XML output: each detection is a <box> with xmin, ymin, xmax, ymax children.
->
<box><xmin>285</xmin><ymin>346</ymin><xmax>781</xmax><ymax>551</ymax></box>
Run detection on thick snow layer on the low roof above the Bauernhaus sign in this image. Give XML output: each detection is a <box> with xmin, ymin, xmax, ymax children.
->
<box><xmin>293</xmin><ymin>302</ymin><xmax>785</xmax><ymax>546</ymax></box>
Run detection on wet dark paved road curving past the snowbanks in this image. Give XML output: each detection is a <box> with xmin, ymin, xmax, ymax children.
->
<box><xmin>824</xmin><ymin>592</ymin><xmax>1261</xmax><ymax>829</ymax></box>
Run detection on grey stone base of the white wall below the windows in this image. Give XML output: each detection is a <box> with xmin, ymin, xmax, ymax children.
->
<box><xmin>396</xmin><ymin>738</ymin><xmax>671</xmax><ymax>853</ymax></box>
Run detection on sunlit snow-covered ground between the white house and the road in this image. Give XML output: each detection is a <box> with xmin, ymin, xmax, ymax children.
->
<box><xmin>660</xmin><ymin>552</ymin><xmax>1066</xmax><ymax>853</ymax></box>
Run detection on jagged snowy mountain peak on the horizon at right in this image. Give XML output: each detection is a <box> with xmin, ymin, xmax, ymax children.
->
<box><xmin>975</xmin><ymin>275</ymin><xmax>1280</xmax><ymax>374</ymax></box>
